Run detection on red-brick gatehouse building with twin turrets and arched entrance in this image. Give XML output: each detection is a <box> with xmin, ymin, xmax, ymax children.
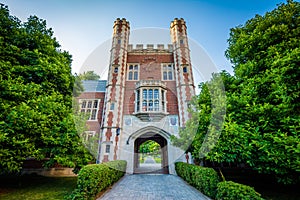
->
<box><xmin>79</xmin><ymin>18</ymin><xmax>195</xmax><ymax>173</ymax></box>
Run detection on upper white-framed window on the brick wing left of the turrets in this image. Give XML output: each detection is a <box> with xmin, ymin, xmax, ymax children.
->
<box><xmin>79</xmin><ymin>99</ymin><xmax>100</xmax><ymax>120</ymax></box>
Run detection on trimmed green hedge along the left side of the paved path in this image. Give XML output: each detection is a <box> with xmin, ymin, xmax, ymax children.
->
<box><xmin>65</xmin><ymin>160</ymin><xmax>127</xmax><ymax>200</ymax></box>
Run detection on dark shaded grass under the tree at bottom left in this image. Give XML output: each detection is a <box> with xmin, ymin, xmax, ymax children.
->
<box><xmin>0</xmin><ymin>175</ymin><xmax>77</xmax><ymax>200</ymax></box>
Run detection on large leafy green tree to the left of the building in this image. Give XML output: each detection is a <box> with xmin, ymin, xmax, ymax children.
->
<box><xmin>0</xmin><ymin>5</ymin><xmax>92</xmax><ymax>172</ymax></box>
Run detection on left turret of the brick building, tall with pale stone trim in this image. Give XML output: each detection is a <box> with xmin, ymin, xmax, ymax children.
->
<box><xmin>99</xmin><ymin>18</ymin><xmax>130</xmax><ymax>162</ymax></box>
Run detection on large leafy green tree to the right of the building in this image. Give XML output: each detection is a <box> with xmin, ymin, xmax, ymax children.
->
<box><xmin>172</xmin><ymin>1</ymin><xmax>300</xmax><ymax>183</ymax></box>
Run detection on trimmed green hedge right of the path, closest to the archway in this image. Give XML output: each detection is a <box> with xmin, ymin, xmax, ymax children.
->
<box><xmin>175</xmin><ymin>162</ymin><xmax>220</xmax><ymax>198</ymax></box>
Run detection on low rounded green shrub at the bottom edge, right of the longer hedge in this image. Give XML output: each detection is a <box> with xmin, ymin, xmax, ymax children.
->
<box><xmin>216</xmin><ymin>181</ymin><xmax>262</xmax><ymax>200</ymax></box>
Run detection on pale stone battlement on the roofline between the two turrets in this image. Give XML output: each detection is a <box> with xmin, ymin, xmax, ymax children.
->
<box><xmin>128</xmin><ymin>44</ymin><xmax>173</xmax><ymax>53</ymax></box>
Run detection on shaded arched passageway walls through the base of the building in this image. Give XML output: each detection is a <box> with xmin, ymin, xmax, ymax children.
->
<box><xmin>133</xmin><ymin>131</ymin><xmax>169</xmax><ymax>174</ymax></box>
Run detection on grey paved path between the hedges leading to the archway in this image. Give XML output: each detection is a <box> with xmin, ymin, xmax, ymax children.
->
<box><xmin>98</xmin><ymin>174</ymin><xmax>209</xmax><ymax>200</ymax></box>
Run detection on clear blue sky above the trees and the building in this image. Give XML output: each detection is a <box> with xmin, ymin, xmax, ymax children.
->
<box><xmin>2</xmin><ymin>0</ymin><xmax>286</xmax><ymax>76</ymax></box>
